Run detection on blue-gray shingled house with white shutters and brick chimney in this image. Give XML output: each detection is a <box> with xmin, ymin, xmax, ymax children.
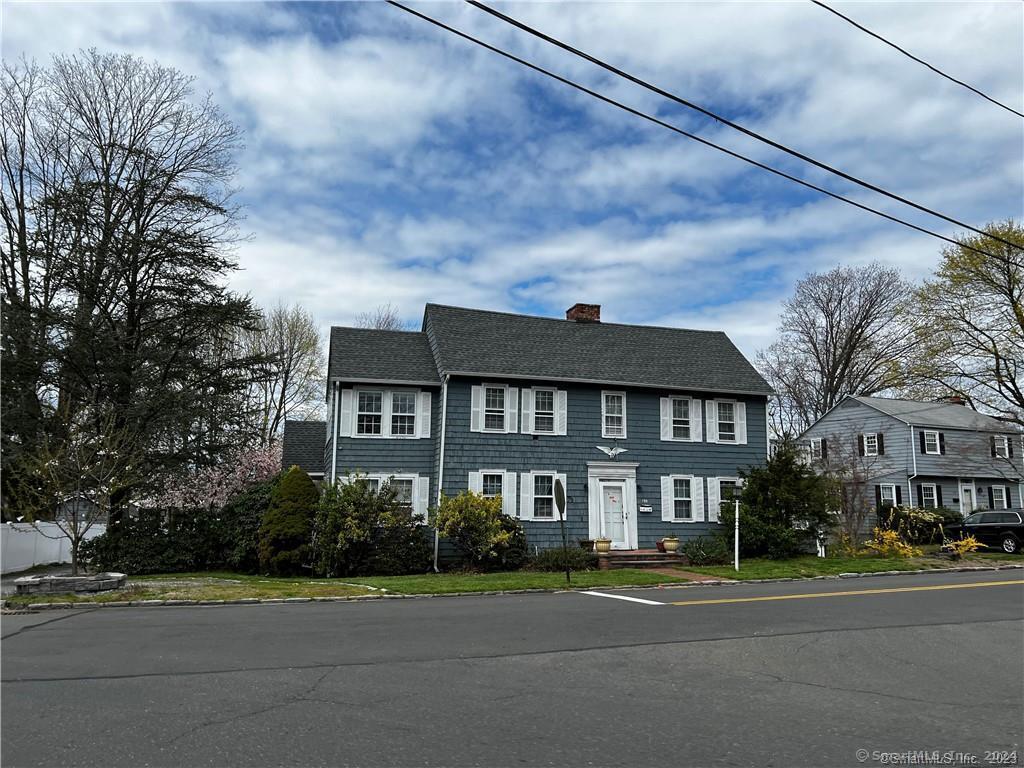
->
<box><xmin>285</xmin><ymin>304</ymin><xmax>771</xmax><ymax>549</ymax></box>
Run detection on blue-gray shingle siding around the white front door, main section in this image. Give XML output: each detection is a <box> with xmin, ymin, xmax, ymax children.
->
<box><xmin>443</xmin><ymin>378</ymin><xmax>768</xmax><ymax>550</ymax></box>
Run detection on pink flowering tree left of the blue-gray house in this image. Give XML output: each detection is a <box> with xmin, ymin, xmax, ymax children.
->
<box><xmin>156</xmin><ymin>443</ymin><xmax>281</xmax><ymax>509</ymax></box>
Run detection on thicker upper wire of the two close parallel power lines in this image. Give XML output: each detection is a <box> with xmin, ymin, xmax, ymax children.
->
<box><xmin>466</xmin><ymin>0</ymin><xmax>1024</xmax><ymax>250</ymax></box>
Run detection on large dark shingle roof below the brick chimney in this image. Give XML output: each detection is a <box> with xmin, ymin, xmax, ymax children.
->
<box><xmin>423</xmin><ymin>304</ymin><xmax>772</xmax><ymax>394</ymax></box>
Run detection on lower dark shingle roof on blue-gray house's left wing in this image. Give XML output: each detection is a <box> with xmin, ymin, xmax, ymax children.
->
<box><xmin>328</xmin><ymin>327</ymin><xmax>440</xmax><ymax>384</ymax></box>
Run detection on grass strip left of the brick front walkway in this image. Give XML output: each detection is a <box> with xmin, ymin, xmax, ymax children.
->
<box><xmin>7</xmin><ymin>568</ymin><xmax>686</xmax><ymax>607</ymax></box>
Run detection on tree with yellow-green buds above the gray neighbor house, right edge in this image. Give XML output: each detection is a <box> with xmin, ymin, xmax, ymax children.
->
<box><xmin>915</xmin><ymin>221</ymin><xmax>1024</xmax><ymax>425</ymax></box>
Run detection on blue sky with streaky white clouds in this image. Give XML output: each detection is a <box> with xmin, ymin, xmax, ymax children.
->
<box><xmin>0</xmin><ymin>2</ymin><xmax>1024</xmax><ymax>354</ymax></box>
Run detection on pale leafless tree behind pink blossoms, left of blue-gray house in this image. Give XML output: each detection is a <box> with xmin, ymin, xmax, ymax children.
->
<box><xmin>245</xmin><ymin>303</ymin><xmax>325</xmax><ymax>445</ymax></box>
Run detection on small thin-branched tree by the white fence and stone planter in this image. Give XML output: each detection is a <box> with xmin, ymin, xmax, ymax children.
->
<box><xmin>22</xmin><ymin>417</ymin><xmax>144</xmax><ymax>575</ymax></box>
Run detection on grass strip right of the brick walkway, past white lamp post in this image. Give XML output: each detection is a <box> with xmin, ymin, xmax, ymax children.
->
<box><xmin>687</xmin><ymin>553</ymin><xmax>1024</xmax><ymax>580</ymax></box>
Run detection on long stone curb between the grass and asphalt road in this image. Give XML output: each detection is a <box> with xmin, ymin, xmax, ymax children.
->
<box><xmin>0</xmin><ymin>565</ymin><xmax>1024</xmax><ymax>613</ymax></box>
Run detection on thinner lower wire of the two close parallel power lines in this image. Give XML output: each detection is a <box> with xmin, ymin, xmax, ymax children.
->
<box><xmin>387</xmin><ymin>0</ymin><xmax>1013</xmax><ymax>258</ymax></box>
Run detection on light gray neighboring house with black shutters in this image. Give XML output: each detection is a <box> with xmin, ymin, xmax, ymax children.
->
<box><xmin>801</xmin><ymin>396</ymin><xmax>1024</xmax><ymax>515</ymax></box>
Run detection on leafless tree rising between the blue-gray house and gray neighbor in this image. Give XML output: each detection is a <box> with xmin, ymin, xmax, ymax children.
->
<box><xmin>758</xmin><ymin>264</ymin><xmax>914</xmax><ymax>436</ymax></box>
